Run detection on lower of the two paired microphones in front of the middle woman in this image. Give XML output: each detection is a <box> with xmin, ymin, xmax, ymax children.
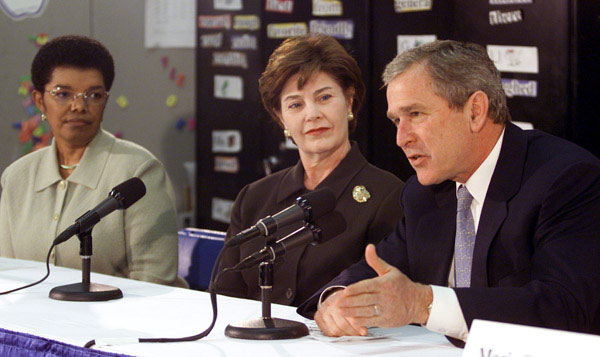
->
<box><xmin>233</xmin><ymin>211</ymin><xmax>346</xmax><ymax>271</ymax></box>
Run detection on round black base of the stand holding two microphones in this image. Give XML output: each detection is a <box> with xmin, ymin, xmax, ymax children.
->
<box><xmin>225</xmin><ymin>317</ymin><xmax>308</xmax><ymax>340</ymax></box>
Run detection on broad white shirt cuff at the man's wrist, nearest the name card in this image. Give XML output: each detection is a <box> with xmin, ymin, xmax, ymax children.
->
<box><xmin>425</xmin><ymin>285</ymin><xmax>469</xmax><ymax>341</ymax></box>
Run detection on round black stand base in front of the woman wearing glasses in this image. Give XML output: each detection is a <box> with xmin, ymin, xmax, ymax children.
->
<box><xmin>50</xmin><ymin>283</ymin><xmax>123</xmax><ymax>301</ymax></box>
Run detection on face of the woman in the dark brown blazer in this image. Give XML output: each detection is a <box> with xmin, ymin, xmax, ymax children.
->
<box><xmin>280</xmin><ymin>72</ymin><xmax>354</xmax><ymax>156</ymax></box>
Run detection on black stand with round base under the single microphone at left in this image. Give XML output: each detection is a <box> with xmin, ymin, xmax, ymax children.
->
<box><xmin>50</xmin><ymin>228</ymin><xmax>123</xmax><ymax>301</ymax></box>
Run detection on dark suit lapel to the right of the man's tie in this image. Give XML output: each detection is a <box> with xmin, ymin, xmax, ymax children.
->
<box><xmin>471</xmin><ymin>123</ymin><xmax>527</xmax><ymax>287</ymax></box>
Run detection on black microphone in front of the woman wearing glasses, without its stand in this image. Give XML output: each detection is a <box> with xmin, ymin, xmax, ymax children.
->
<box><xmin>54</xmin><ymin>177</ymin><xmax>146</xmax><ymax>245</ymax></box>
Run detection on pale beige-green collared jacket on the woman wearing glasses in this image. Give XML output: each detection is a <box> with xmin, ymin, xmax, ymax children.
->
<box><xmin>0</xmin><ymin>129</ymin><xmax>185</xmax><ymax>286</ymax></box>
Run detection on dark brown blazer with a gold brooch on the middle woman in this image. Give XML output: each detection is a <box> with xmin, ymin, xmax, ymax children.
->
<box><xmin>217</xmin><ymin>143</ymin><xmax>403</xmax><ymax>306</ymax></box>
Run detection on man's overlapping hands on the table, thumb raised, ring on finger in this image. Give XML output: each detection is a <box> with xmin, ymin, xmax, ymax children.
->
<box><xmin>315</xmin><ymin>244</ymin><xmax>433</xmax><ymax>336</ymax></box>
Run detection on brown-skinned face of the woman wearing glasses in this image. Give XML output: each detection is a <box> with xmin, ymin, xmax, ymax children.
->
<box><xmin>33</xmin><ymin>67</ymin><xmax>108</xmax><ymax>146</ymax></box>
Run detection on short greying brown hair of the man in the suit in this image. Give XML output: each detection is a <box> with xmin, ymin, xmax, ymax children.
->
<box><xmin>382</xmin><ymin>40</ymin><xmax>510</xmax><ymax>123</ymax></box>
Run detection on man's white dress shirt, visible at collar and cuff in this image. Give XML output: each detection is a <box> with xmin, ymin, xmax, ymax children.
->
<box><xmin>425</xmin><ymin>130</ymin><xmax>504</xmax><ymax>341</ymax></box>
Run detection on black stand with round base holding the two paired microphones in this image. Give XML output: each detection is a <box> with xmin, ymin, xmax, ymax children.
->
<box><xmin>225</xmin><ymin>260</ymin><xmax>308</xmax><ymax>340</ymax></box>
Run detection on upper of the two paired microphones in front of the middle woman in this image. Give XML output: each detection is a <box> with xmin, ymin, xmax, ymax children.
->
<box><xmin>225</xmin><ymin>187</ymin><xmax>335</xmax><ymax>247</ymax></box>
